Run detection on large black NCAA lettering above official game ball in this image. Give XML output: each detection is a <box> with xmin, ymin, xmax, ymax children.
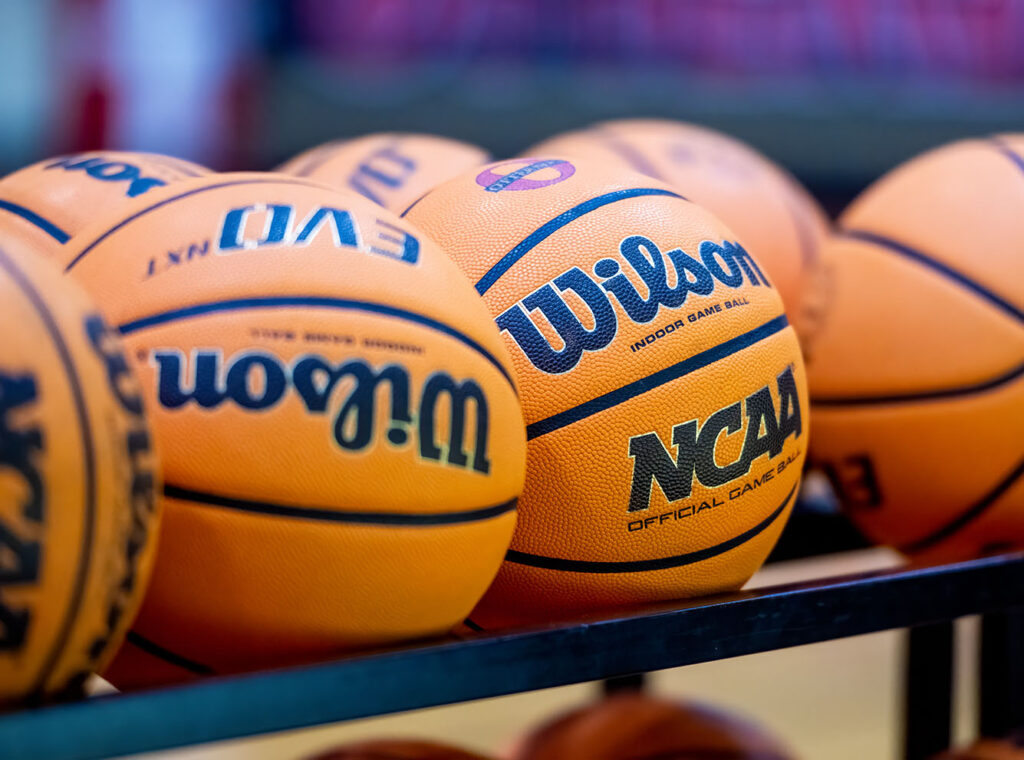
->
<box><xmin>629</xmin><ymin>367</ymin><xmax>803</xmax><ymax>512</ymax></box>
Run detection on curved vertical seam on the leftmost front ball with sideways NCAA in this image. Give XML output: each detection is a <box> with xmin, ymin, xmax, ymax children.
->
<box><xmin>0</xmin><ymin>250</ymin><xmax>96</xmax><ymax>693</ymax></box>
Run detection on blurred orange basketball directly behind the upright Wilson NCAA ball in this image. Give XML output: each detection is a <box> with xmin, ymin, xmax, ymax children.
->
<box><xmin>524</xmin><ymin>119</ymin><xmax>828</xmax><ymax>337</ymax></box>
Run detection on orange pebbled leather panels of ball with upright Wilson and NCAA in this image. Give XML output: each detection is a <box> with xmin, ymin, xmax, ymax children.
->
<box><xmin>410</xmin><ymin>157</ymin><xmax>808</xmax><ymax>627</ymax></box>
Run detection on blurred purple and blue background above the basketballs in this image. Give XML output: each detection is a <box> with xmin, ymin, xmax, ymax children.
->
<box><xmin>6</xmin><ymin>0</ymin><xmax>1024</xmax><ymax>210</ymax></box>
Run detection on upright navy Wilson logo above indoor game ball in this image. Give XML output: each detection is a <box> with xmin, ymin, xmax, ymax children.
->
<box><xmin>496</xmin><ymin>235</ymin><xmax>771</xmax><ymax>374</ymax></box>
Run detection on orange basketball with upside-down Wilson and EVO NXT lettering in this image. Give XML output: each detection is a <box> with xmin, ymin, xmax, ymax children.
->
<box><xmin>58</xmin><ymin>174</ymin><xmax>525</xmax><ymax>686</ymax></box>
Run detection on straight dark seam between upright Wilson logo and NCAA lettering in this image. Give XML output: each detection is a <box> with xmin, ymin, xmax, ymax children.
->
<box><xmin>526</xmin><ymin>313</ymin><xmax>790</xmax><ymax>440</ymax></box>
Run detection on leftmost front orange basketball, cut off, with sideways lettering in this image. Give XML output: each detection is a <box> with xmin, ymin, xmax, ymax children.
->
<box><xmin>0</xmin><ymin>242</ymin><xmax>158</xmax><ymax>704</ymax></box>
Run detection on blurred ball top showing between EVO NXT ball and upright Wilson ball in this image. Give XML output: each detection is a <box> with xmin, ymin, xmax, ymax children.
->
<box><xmin>278</xmin><ymin>132</ymin><xmax>490</xmax><ymax>214</ymax></box>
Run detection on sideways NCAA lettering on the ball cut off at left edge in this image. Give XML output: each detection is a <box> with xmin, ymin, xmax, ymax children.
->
<box><xmin>0</xmin><ymin>372</ymin><xmax>46</xmax><ymax>652</ymax></box>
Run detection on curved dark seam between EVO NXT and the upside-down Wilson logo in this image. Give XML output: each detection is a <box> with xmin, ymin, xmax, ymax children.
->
<box><xmin>118</xmin><ymin>296</ymin><xmax>518</xmax><ymax>393</ymax></box>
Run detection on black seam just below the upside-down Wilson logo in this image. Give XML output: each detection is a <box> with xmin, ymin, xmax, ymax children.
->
<box><xmin>164</xmin><ymin>484</ymin><xmax>516</xmax><ymax>527</ymax></box>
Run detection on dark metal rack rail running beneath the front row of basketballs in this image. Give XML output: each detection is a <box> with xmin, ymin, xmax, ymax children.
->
<box><xmin>0</xmin><ymin>554</ymin><xmax>1024</xmax><ymax>760</ymax></box>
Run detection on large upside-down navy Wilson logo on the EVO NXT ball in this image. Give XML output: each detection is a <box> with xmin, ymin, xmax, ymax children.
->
<box><xmin>151</xmin><ymin>349</ymin><xmax>490</xmax><ymax>474</ymax></box>
